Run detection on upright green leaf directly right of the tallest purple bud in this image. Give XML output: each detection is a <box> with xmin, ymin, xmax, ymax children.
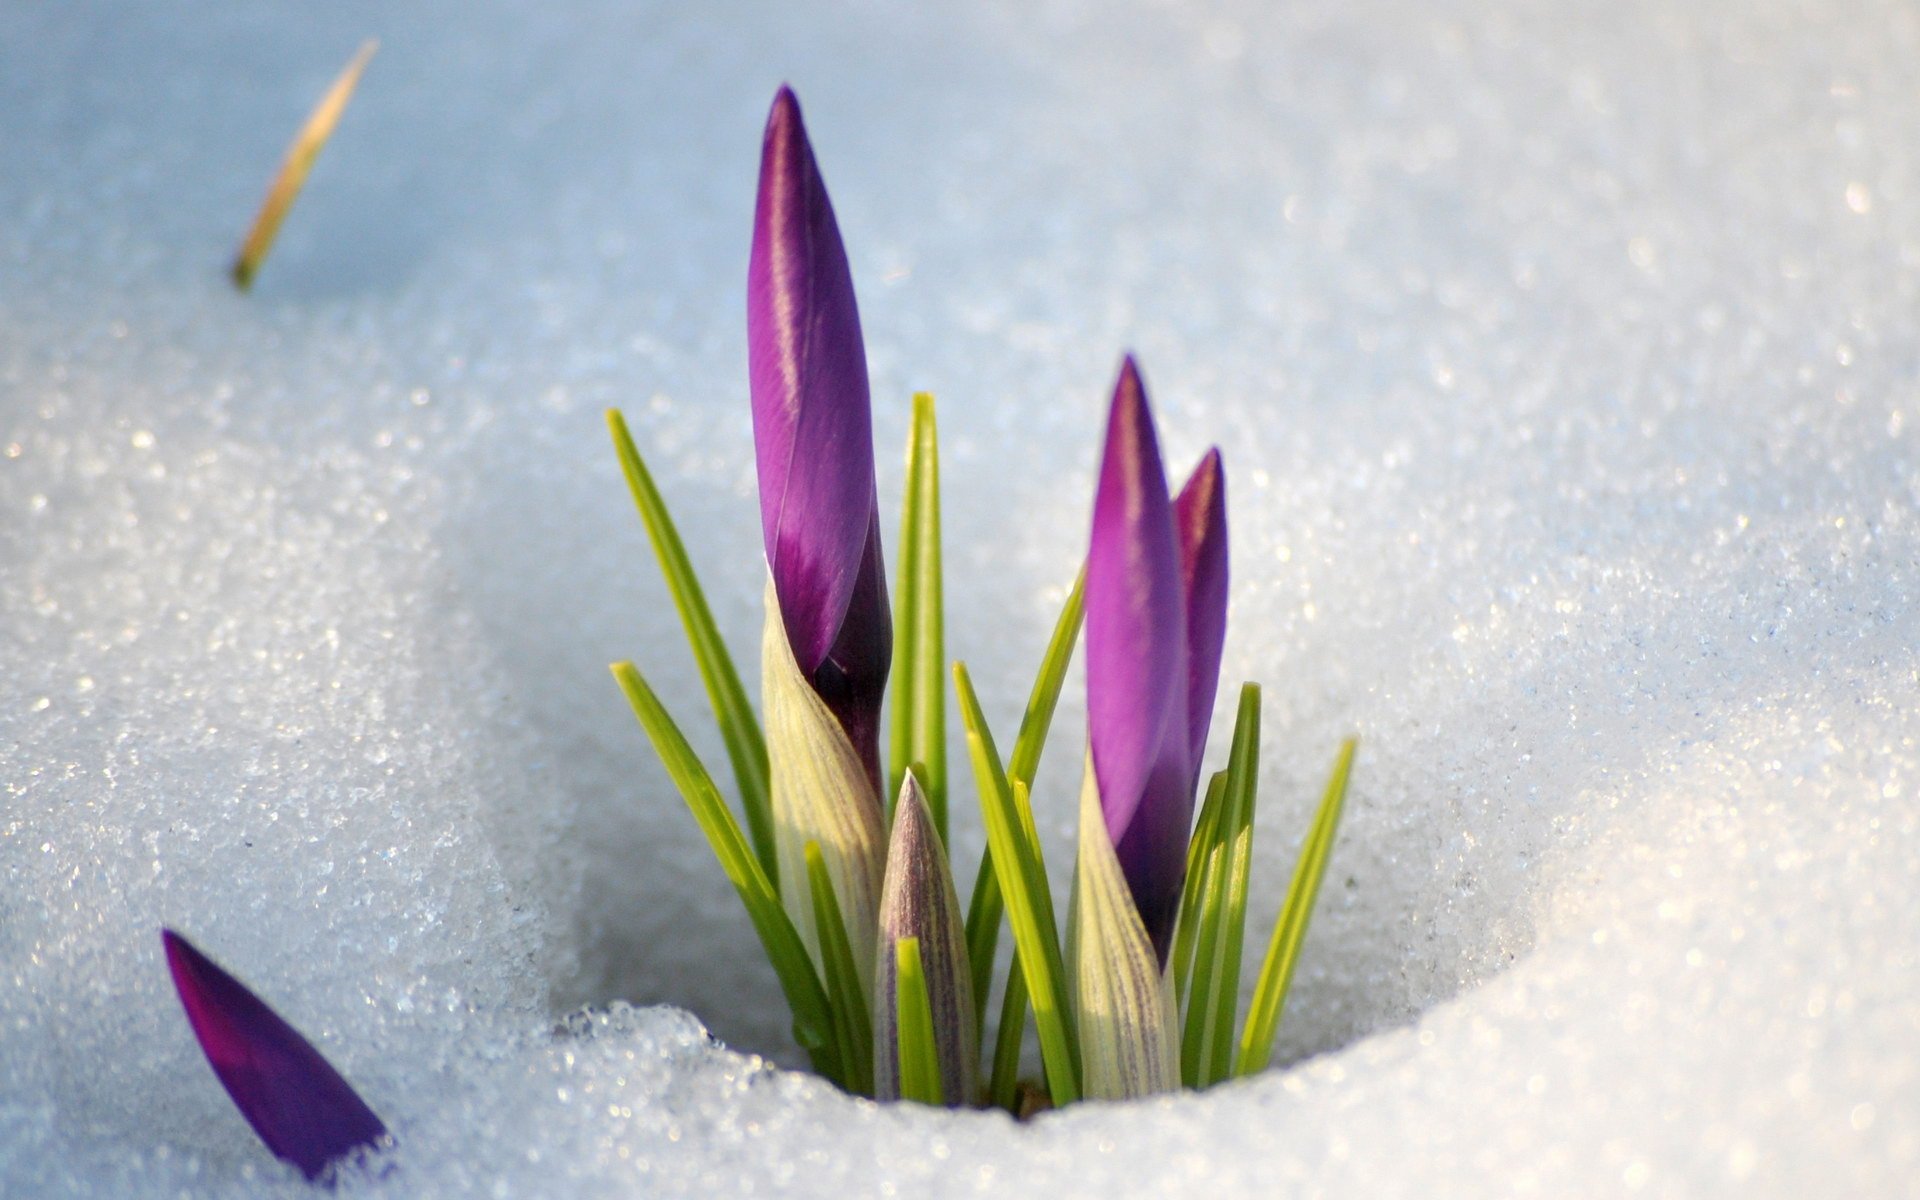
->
<box><xmin>887</xmin><ymin>392</ymin><xmax>947</xmax><ymax>845</ymax></box>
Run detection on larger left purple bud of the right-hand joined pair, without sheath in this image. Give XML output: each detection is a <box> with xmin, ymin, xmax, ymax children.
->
<box><xmin>1087</xmin><ymin>357</ymin><xmax>1190</xmax><ymax>962</ymax></box>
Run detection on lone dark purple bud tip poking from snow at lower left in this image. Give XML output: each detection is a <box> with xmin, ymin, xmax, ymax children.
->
<box><xmin>159</xmin><ymin>929</ymin><xmax>386</xmax><ymax>1179</ymax></box>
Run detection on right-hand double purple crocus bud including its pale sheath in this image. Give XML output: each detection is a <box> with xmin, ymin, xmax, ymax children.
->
<box><xmin>1069</xmin><ymin>357</ymin><xmax>1227</xmax><ymax>1098</ymax></box>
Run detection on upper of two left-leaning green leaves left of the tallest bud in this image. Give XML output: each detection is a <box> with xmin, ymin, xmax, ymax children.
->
<box><xmin>607</xmin><ymin>409</ymin><xmax>780</xmax><ymax>883</ymax></box>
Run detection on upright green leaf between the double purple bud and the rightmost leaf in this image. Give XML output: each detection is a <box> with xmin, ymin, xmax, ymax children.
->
<box><xmin>1181</xmin><ymin>684</ymin><xmax>1260</xmax><ymax>1087</ymax></box>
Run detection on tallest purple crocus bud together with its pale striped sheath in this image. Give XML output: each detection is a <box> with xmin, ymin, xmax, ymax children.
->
<box><xmin>747</xmin><ymin>88</ymin><xmax>893</xmax><ymax>991</ymax></box>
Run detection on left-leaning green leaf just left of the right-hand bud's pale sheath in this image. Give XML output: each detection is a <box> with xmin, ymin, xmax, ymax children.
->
<box><xmin>954</xmin><ymin>662</ymin><xmax>1079</xmax><ymax>1104</ymax></box>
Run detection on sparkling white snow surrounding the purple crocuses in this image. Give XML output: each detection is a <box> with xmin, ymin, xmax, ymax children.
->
<box><xmin>0</xmin><ymin>0</ymin><xmax>1920</xmax><ymax>1198</ymax></box>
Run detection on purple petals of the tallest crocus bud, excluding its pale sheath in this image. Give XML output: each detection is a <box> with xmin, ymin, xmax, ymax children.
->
<box><xmin>747</xmin><ymin>86</ymin><xmax>893</xmax><ymax>791</ymax></box>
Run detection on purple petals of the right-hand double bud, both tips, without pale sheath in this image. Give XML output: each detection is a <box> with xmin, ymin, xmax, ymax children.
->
<box><xmin>1087</xmin><ymin>357</ymin><xmax>1227</xmax><ymax>964</ymax></box>
